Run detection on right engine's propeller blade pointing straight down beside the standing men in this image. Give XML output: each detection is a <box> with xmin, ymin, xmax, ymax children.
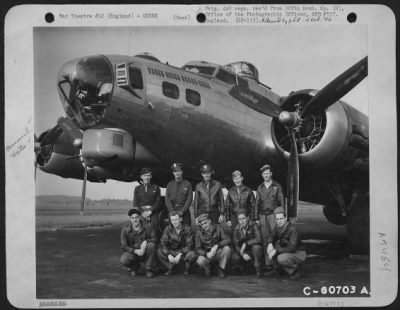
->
<box><xmin>287</xmin><ymin>130</ymin><xmax>299</xmax><ymax>218</ymax></box>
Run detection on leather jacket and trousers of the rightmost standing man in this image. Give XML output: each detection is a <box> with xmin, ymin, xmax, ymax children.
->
<box><xmin>254</xmin><ymin>180</ymin><xmax>284</xmax><ymax>267</ymax></box>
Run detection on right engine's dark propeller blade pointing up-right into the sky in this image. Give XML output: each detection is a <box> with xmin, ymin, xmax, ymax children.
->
<box><xmin>301</xmin><ymin>56</ymin><xmax>368</xmax><ymax>118</ymax></box>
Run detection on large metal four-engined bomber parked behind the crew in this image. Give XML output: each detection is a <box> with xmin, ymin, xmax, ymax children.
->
<box><xmin>35</xmin><ymin>53</ymin><xmax>369</xmax><ymax>252</ymax></box>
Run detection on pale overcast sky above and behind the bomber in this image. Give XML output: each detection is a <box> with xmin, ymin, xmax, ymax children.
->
<box><xmin>34</xmin><ymin>24</ymin><xmax>368</xmax><ymax>199</ymax></box>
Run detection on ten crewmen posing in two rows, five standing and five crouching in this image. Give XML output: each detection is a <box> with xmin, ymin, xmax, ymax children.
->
<box><xmin>120</xmin><ymin>163</ymin><xmax>306</xmax><ymax>280</ymax></box>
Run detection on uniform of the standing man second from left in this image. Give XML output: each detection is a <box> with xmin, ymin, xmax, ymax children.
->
<box><xmin>165</xmin><ymin>180</ymin><xmax>193</xmax><ymax>226</ymax></box>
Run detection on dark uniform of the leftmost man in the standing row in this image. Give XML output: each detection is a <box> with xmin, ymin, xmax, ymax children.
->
<box><xmin>133</xmin><ymin>183</ymin><xmax>162</xmax><ymax>238</ymax></box>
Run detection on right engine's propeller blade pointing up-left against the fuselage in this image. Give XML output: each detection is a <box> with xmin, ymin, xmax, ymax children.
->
<box><xmin>228</xmin><ymin>85</ymin><xmax>282</xmax><ymax>117</ymax></box>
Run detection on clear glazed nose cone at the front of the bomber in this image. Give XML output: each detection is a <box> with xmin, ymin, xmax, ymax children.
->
<box><xmin>57</xmin><ymin>56</ymin><xmax>114</xmax><ymax>129</ymax></box>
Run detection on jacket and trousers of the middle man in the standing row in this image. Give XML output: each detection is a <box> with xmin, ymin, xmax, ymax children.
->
<box><xmin>194</xmin><ymin>180</ymin><xmax>225</xmax><ymax>224</ymax></box>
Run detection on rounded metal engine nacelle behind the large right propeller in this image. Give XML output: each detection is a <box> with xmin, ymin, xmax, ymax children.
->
<box><xmin>272</xmin><ymin>90</ymin><xmax>368</xmax><ymax>169</ymax></box>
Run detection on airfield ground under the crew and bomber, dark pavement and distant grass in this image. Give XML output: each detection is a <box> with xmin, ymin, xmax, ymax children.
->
<box><xmin>36</xmin><ymin>203</ymin><xmax>370</xmax><ymax>299</ymax></box>
